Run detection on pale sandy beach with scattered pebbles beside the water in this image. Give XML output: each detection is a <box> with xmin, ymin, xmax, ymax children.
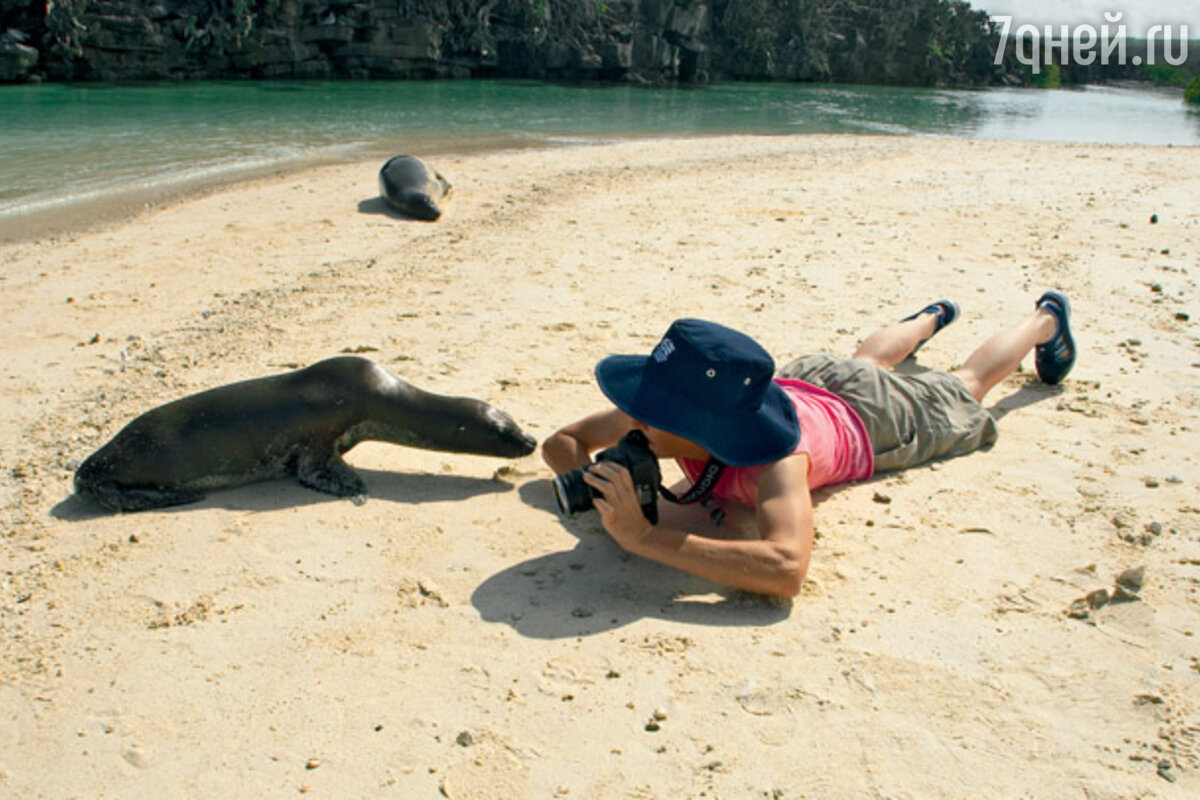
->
<box><xmin>0</xmin><ymin>137</ymin><xmax>1200</xmax><ymax>800</ymax></box>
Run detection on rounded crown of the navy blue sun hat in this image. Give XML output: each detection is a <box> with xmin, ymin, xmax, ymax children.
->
<box><xmin>646</xmin><ymin>319</ymin><xmax>775</xmax><ymax>414</ymax></box>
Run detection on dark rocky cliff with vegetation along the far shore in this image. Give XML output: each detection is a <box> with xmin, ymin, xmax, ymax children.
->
<box><xmin>0</xmin><ymin>0</ymin><xmax>1016</xmax><ymax>85</ymax></box>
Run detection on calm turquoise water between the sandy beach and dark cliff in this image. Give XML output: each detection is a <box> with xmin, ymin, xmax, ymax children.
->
<box><xmin>0</xmin><ymin>82</ymin><xmax>1200</xmax><ymax>239</ymax></box>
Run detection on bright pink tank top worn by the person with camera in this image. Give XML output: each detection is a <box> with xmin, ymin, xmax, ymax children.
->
<box><xmin>677</xmin><ymin>378</ymin><xmax>875</xmax><ymax>509</ymax></box>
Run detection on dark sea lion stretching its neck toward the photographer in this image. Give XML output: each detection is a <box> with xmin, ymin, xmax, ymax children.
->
<box><xmin>74</xmin><ymin>356</ymin><xmax>536</xmax><ymax>511</ymax></box>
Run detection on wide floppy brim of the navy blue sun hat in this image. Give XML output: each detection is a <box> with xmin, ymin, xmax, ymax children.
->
<box><xmin>595</xmin><ymin>355</ymin><xmax>800</xmax><ymax>467</ymax></box>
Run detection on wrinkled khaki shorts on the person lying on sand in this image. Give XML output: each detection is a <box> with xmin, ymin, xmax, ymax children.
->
<box><xmin>779</xmin><ymin>355</ymin><xmax>998</xmax><ymax>473</ymax></box>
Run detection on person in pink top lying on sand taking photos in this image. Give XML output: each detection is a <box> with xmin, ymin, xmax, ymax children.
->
<box><xmin>542</xmin><ymin>290</ymin><xmax>1075</xmax><ymax>596</ymax></box>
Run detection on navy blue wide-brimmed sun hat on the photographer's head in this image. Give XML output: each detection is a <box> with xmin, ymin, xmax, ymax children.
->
<box><xmin>595</xmin><ymin>319</ymin><xmax>800</xmax><ymax>467</ymax></box>
